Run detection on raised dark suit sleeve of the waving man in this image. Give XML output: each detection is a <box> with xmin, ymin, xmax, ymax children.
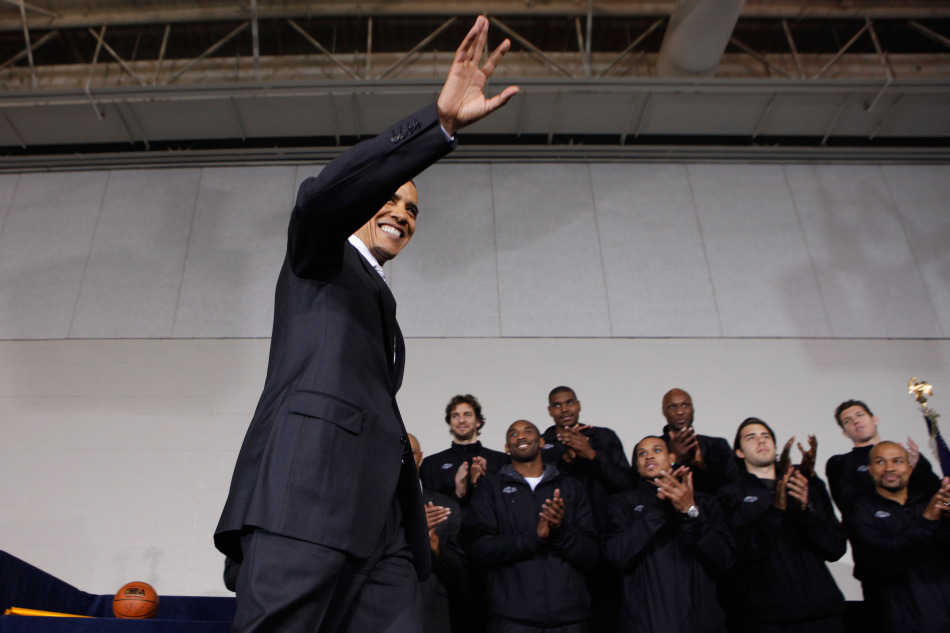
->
<box><xmin>287</xmin><ymin>104</ymin><xmax>455</xmax><ymax>279</ymax></box>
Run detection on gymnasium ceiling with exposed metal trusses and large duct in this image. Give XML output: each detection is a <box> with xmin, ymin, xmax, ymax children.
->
<box><xmin>0</xmin><ymin>0</ymin><xmax>950</xmax><ymax>171</ymax></box>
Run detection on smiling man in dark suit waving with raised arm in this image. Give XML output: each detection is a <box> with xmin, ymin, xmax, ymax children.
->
<box><xmin>215</xmin><ymin>17</ymin><xmax>517</xmax><ymax>633</ymax></box>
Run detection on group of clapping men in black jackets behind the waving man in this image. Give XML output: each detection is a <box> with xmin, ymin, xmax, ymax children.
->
<box><xmin>412</xmin><ymin>386</ymin><xmax>950</xmax><ymax>633</ymax></box>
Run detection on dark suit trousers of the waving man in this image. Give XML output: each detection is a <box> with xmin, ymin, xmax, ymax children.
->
<box><xmin>231</xmin><ymin>500</ymin><xmax>424</xmax><ymax>633</ymax></box>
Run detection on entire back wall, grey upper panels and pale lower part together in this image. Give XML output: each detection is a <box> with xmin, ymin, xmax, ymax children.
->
<box><xmin>0</xmin><ymin>163</ymin><xmax>950</xmax><ymax>597</ymax></box>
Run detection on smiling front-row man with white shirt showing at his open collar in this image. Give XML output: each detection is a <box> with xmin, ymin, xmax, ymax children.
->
<box><xmin>465</xmin><ymin>420</ymin><xmax>598</xmax><ymax>633</ymax></box>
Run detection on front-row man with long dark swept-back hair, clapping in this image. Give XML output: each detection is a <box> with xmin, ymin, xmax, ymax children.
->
<box><xmin>718</xmin><ymin>418</ymin><xmax>847</xmax><ymax>633</ymax></box>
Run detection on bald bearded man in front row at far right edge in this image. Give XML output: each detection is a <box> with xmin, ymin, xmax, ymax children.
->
<box><xmin>844</xmin><ymin>441</ymin><xmax>950</xmax><ymax>633</ymax></box>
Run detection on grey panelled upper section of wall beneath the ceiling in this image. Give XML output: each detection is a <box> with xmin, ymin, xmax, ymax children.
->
<box><xmin>0</xmin><ymin>163</ymin><xmax>950</xmax><ymax>339</ymax></box>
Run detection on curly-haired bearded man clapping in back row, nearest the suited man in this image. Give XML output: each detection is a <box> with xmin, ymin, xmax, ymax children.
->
<box><xmin>419</xmin><ymin>393</ymin><xmax>508</xmax><ymax>506</ymax></box>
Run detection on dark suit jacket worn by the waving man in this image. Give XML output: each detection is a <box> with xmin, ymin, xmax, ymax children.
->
<box><xmin>215</xmin><ymin>105</ymin><xmax>454</xmax><ymax>576</ymax></box>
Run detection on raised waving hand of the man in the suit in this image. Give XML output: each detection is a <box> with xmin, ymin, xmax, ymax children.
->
<box><xmin>438</xmin><ymin>15</ymin><xmax>518</xmax><ymax>136</ymax></box>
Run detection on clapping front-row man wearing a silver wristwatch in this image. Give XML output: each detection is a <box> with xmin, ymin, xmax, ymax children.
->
<box><xmin>604</xmin><ymin>436</ymin><xmax>735</xmax><ymax>633</ymax></box>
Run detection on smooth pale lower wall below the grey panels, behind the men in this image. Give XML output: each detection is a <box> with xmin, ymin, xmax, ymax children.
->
<box><xmin>0</xmin><ymin>338</ymin><xmax>950</xmax><ymax>598</ymax></box>
